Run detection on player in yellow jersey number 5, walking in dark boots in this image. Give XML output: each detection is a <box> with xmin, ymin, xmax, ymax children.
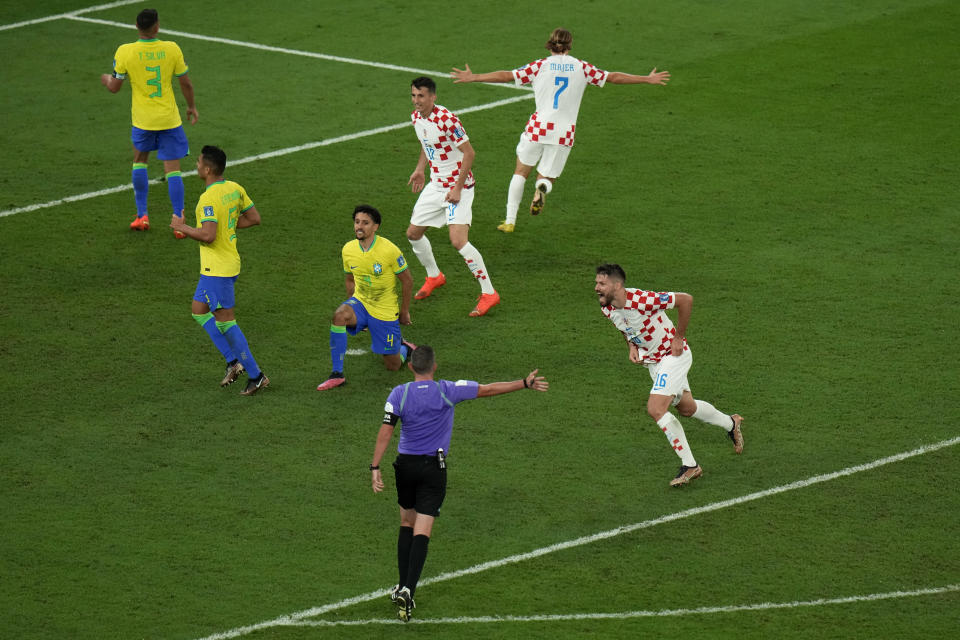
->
<box><xmin>170</xmin><ymin>146</ymin><xmax>270</xmax><ymax>396</ymax></box>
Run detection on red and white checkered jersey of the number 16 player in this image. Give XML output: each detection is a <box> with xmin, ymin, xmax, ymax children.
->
<box><xmin>600</xmin><ymin>289</ymin><xmax>690</xmax><ymax>364</ymax></box>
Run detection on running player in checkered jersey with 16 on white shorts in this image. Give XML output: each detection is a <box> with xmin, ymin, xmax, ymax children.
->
<box><xmin>594</xmin><ymin>264</ymin><xmax>743</xmax><ymax>487</ymax></box>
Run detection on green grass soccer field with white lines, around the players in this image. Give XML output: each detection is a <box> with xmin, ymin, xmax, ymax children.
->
<box><xmin>0</xmin><ymin>0</ymin><xmax>960</xmax><ymax>640</ymax></box>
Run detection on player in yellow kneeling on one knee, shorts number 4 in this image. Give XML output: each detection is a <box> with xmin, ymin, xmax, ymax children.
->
<box><xmin>317</xmin><ymin>204</ymin><xmax>416</xmax><ymax>391</ymax></box>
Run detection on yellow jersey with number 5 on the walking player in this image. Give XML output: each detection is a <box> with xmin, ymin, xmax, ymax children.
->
<box><xmin>196</xmin><ymin>180</ymin><xmax>253</xmax><ymax>277</ymax></box>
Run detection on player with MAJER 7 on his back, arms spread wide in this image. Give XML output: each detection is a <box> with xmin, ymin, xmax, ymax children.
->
<box><xmin>450</xmin><ymin>29</ymin><xmax>670</xmax><ymax>233</ymax></box>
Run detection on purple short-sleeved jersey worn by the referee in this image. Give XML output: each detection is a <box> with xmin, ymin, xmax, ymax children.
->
<box><xmin>383</xmin><ymin>380</ymin><xmax>480</xmax><ymax>455</ymax></box>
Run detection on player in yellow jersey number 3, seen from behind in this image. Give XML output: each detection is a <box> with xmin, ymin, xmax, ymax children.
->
<box><xmin>100</xmin><ymin>9</ymin><xmax>199</xmax><ymax>238</ymax></box>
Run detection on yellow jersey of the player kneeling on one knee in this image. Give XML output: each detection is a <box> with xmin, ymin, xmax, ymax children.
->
<box><xmin>343</xmin><ymin>236</ymin><xmax>407</xmax><ymax>320</ymax></box>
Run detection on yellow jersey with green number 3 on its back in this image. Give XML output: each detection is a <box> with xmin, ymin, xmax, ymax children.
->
<box><xmin>113</xmin><ymin>40</ymin><xmax>189</xmax><ymax>131</ymax></box>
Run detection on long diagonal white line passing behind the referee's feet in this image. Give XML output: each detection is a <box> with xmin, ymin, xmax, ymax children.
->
<box><xmin>193</xmin><ymin>436</ymin><xmax>960</xmax><ymax>640</ymax></box>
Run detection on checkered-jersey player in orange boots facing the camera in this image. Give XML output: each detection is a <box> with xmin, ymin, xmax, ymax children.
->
<box><xmin>407</xmin><ymin>77</ymin><xmax>500</xmax><ymax>317</ymax></box>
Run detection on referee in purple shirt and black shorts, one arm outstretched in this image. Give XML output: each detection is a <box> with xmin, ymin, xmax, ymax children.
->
<box><xmin>370</xmin><ymin>345</ymin><xmax>550</xmax><ymax>622</ymax></box>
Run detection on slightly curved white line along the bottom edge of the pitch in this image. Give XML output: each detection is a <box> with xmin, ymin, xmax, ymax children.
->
<box><xmin>286</xmin><ymin>584</ymin><xmax>960</xmax><ymax>627</ymax></box>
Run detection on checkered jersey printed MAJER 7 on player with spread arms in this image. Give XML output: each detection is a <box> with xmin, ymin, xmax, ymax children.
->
<box><xmin>513</xmin><ymin>55</ymin><xmax>608</xmax><ymax>147</ymax></box>
